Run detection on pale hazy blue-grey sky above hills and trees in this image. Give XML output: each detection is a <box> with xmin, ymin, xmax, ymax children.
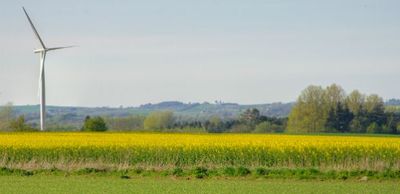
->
<box><xmin>0</xmin><ymin>0</ymin><xmax>400</xmax><ymax>106</ymax></box>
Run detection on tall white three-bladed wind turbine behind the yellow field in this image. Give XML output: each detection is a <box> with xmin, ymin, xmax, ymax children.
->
<box><xmin>22</xmin><ymin>7</ymin><xmax>73</xmax><ymax>131</ymax></box>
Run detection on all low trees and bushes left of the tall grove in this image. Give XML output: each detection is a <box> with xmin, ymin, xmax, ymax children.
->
<box><xmin>0</xmin><ymin>104</ymin><xmax>287</xmax><ymax>133</ymax></box>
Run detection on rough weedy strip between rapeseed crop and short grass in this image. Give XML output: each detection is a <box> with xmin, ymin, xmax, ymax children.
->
<box><xmin>0</xmin><ymin>166</ymin><xmax>400</xmax><ymax>181</ymax></box>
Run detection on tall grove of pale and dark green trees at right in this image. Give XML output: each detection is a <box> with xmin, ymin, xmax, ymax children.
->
<box><xmin>287</xmin><ymin>84</ymin><xmax>400</xmax><ymax>133</ymax></box>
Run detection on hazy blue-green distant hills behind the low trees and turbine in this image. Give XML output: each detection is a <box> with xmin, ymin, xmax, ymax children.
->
<box><xmin>14</xmin><ymin>101</ymin><xmax>293</xmax><ymax>126</ymax></box>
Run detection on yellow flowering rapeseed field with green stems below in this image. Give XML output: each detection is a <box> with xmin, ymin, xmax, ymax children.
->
<box><xmin>0</xmin><ymin>132</ymin><xmax>400</xmax><ymax>169</ymax></box>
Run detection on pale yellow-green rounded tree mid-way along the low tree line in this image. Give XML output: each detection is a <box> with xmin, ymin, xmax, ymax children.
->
<box><xmin>144</xmin><ymin>111</ymin><xmax>175</xmax><ymax>130</ymax></box>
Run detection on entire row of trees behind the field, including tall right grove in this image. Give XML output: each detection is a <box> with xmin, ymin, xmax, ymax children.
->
<box><xmin>0</xmin><ymin>84</ymin><xmax>400</xmax><ymax>134</ymax></box>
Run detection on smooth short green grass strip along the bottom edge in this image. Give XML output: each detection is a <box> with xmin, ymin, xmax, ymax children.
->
<box><xmin>0</xmin><ymin>176</ymin><xmax>400</xmax><ymax>194</ymax></box>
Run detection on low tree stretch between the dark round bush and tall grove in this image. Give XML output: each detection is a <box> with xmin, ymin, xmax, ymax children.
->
<box><xmin>99</xmin><ymin>108</ymin><xmax>287</xmax><ymax>133</ymax></box>
